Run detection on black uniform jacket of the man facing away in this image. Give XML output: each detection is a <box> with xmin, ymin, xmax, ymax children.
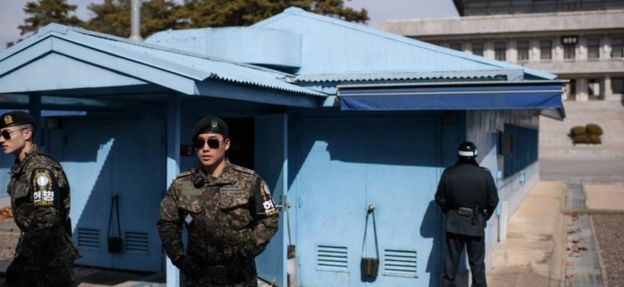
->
<box><xmin>435</xmin><ymin>163</ymin><xmax>498</xmax><ymax>237</ymax></box>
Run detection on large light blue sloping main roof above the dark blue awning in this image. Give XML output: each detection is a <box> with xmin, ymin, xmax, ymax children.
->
<box><xmin>252</xmin><ymin>8</ymin><xmax>557</xmax><ymax>81</ymax></box>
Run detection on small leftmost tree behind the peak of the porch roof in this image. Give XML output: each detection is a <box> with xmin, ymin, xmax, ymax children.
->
<box><xmin>18</xmin><ymin>0</ymin><xmax>82</xmax><ymax>36</ymax></box>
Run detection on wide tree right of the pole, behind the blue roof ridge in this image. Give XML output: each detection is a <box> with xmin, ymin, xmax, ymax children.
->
<box><xmin>178</xmin><ymin>0</ymin><xmax>368</xmax><ymax>28</ymax></box>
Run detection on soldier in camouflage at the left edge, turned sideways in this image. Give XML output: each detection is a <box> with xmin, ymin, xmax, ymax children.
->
<box><xmin>0</xmin><ymin>111</ymin><xmax>80</xmax><ymax>287</ymax></box>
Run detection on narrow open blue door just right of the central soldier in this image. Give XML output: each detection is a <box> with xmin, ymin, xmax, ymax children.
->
<box><xmin>254</xmin><ymin>114</ymin><xmax>288</xmax><ymax>286</ymax></box>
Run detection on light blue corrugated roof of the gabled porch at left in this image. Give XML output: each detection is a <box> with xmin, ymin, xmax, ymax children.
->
<box><xmin>0</xmin><ymin>24</ymin><xmax>325</xmax><ymax>96</ymax></box>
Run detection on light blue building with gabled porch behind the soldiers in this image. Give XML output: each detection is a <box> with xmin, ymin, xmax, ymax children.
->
<box><xmin>0</xmin><ymin>8</ymin><xmax>563</xmax><ymax>286</ymax></box>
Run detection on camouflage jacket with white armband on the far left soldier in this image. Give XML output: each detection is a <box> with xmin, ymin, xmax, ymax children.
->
<box><xmin>7</xmin><ymin>145</ymin><xmax>80</xmax><ymax>270</ymax></box>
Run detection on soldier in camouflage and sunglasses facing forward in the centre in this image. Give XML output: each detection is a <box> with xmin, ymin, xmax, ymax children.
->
<box><xmin>158</xmin><ymin>117</ymin><xmax>278</xmax><ymax>287</ymax></box>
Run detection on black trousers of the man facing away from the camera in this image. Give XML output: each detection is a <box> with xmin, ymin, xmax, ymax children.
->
<box><xmin>442</xmin><ymin>232</ymin><xmax>487</xmax><ymax>287</ymax></box>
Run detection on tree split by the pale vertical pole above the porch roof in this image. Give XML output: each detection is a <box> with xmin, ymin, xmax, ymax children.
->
<box><xmin>85</xmin><ymin>0</ymin><xmax>179</xmax><ymax>37</ymax></box>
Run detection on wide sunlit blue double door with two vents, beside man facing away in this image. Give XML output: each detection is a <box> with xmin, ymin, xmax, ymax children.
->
<box><xmin>293</xmin><ymin>117</ymin><xmax>441</xmax><ymax>287</ymax></box>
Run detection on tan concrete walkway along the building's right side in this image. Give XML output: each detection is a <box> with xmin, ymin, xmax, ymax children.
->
<box><xmin>488</xmin><ymin>181</ymin><xmax>565</xmax><ymax>287</ymax></box>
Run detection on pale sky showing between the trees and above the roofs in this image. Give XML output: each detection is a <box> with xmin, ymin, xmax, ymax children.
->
<box><xmin>0</xmin><ymin>0</ymin><xmax>458</xmax><ymax>50</ymax></box>
